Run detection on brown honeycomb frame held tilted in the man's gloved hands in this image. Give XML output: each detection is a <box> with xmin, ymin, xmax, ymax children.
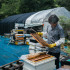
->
<box><xmin>31</xmin><ymin>33</ymin><xmax>49</xmax><ymax>47</ymax></box>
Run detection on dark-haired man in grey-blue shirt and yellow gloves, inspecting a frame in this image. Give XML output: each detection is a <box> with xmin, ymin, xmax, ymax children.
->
<box><xmin>43</xmin><ymin>14</ymin><xmax>65</xmax><ymax>69</ymax></box>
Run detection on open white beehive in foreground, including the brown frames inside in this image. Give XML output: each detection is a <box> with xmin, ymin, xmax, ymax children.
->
<box><xmin>23</xmin><ymin>54</ymin><xmax>56</xmax><ymax>70</ymax></box>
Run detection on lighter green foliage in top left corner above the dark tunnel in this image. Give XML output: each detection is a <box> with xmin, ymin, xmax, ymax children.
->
<box><xmin>0</xmin><ymin>0</ymin><xmax>20</xmax><ymax>19</ymax></box>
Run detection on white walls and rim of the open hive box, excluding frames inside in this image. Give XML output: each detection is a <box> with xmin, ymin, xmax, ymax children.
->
<box><xmin>23</xmin><ymin>57</ymin><xmax>56</xmax><ymax>70</ymax></box>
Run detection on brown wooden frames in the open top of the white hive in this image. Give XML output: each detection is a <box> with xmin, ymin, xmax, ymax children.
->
<box><xmin>27</xmin><ymin>52</ymin><xmax>53</xmax><ymax>62</ymax></box>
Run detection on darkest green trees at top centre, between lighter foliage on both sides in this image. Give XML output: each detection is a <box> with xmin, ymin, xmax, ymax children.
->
<box><xmin>19</xmin><ymin>0</ymin><xmax>54</xmax><ymax>13</ymax></box>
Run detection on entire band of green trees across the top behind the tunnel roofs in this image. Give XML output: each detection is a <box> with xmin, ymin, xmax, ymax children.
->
<box><xmin>0</xmin><ymin>0</ymin><xmax>70</xmax><ymax>20</ymax></box>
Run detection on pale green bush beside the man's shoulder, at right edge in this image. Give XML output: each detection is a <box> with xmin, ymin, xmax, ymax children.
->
<box><xmin>59</xmin><ymin>16</ymin><xmax>70</xmax><ymax>39</ymax></box>
